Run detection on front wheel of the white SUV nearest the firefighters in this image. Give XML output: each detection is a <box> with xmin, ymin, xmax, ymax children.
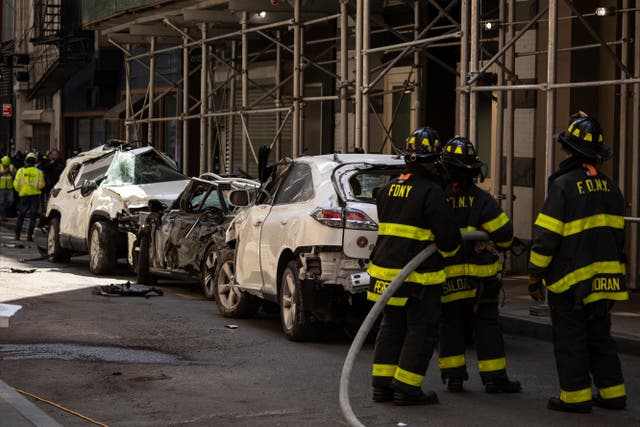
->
<box><xmin>213</xmin><ymin>249</ymin><xmax>260</xmax><ymax>318</ymax></box>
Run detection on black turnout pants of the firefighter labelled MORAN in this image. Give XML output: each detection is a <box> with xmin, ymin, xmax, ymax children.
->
<box><xmin>549</xmin><ymin>291</ymin><xmax>626</xmax><ymax>404</ymax></box>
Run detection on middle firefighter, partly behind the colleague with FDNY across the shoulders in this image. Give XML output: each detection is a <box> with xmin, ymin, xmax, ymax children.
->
<box><xmin>438</xmin><ymin>136</ymin><xmax>521</xmax><ymax>393</ymax></box>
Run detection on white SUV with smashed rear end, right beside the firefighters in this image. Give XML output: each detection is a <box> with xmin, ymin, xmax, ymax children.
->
<box><xmin>214</xmin><ymin>154</ymin><xmax>404</xmax><ymax>341</ymax></box>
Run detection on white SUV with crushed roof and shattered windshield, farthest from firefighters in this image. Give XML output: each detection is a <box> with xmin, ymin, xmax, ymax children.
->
<box><xmin>47</xmin><ymin>144</ymin><xmax>189</xmax><ymax>274</ymax></box>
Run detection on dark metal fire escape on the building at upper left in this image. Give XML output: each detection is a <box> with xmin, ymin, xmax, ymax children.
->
<box><xmin>27</xmin><ymin>0</ymin><xmax>93</xmax><ymax>100</ymax></box>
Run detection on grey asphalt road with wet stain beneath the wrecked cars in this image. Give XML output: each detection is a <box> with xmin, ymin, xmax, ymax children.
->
<box><xmin>0</xmin><ymin>229</ymin><xmax>640</xmax><ymax>426</ymax></box>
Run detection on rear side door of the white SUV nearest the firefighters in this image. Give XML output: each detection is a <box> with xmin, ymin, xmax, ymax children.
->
<box><xmin>260</xmin><ymin>163</ymin><xmax>313</xmax><ymax>294</ymax></box>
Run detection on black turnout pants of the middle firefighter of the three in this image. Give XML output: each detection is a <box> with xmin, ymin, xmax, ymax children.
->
<box><xmin>438</xmin><ymin>280</ymin><xmax>507</xmax><ymax>384</ymax></box>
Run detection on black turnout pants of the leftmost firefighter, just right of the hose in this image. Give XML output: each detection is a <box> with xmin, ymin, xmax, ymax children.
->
<box><xmin>372</xmin><ymin>285</ymin><xmax>442</xmax><ymax>394</ymax></box>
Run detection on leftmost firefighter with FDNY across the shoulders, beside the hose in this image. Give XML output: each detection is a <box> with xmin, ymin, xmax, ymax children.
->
<box><xmin>367</xmin><ymin>127</ymin><xmax>460</xmax><ymax>405</ymax></box>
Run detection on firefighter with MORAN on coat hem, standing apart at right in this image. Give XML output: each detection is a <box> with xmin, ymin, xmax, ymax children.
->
<box><xmin>529</xmin><ymin>112</ymin><xmax>628</xmax><ymax>413</ymax></box>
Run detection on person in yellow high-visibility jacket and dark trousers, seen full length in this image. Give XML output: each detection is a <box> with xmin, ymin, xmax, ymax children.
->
<box><xmin>13</xmin><ymin>153</ymin><xmax>45</xmax><ymax>242</ymax></box>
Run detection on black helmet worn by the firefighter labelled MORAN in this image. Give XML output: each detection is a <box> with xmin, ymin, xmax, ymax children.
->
<box><xmin>556</xmin><ymin>111</ymin><xmax>613</xmax><ymax>162</ymax></box>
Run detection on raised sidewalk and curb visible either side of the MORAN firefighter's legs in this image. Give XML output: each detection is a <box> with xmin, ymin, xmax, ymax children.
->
<box><xmin>500</xmin><ymin>276</ymin><xmax>640</xmax><ymax>355</ymax></box>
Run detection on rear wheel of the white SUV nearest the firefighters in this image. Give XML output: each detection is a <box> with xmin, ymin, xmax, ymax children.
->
<box><xmin>279</xmin><ymin>261</ymin><xmax>318</xmax><ymax>341</ymax></box>
